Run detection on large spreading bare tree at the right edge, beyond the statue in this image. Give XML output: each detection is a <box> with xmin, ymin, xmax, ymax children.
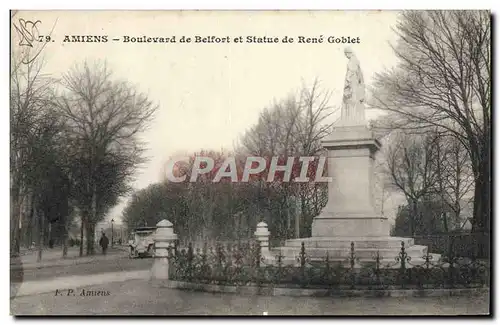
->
<box><xmin>372</xmin><ymin>10</ymin><xmax>491</xmax><ymax>243</ymax></box>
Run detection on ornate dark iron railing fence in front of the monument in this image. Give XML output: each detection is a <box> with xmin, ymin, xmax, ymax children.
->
<box><xmin>169</xmin><ymin>242</ymin><xmax>490</xmax><ymax>290</ymax></box>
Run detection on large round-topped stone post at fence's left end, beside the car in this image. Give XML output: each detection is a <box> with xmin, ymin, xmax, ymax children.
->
<box><xmin>151</xmin><ymin>219</ymin><xmax>177</xmax><ymax>281</ymax></box>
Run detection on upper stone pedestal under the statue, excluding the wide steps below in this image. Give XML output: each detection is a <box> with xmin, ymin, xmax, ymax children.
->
<box><xmin>312</xmin><ymin>126</ymin><xmax>390</xmax><ymax>237</ymax></box>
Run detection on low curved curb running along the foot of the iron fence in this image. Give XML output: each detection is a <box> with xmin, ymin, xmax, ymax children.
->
<box><xmin>159</xmin><ymin>280</ymin><xmax>490</xmax><ymax>297</ymax></box>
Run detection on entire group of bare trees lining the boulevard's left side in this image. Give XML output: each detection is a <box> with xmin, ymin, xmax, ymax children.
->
<box><xmin>10</xmin><ymin>12</ymin><xmax>156</xmax><ymax>259</ymax></box>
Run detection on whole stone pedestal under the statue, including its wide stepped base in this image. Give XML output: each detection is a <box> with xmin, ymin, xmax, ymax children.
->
<box><xmin>271</xmin><ymin>124</ymin><xmax>440</xmax><ymax>265</ymax></box>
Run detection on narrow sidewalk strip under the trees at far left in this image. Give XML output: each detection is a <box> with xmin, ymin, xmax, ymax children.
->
<box><xmin>10</xmin><ymin>246</ymin><xmax>127</xmax><ymax>270</ymax></box>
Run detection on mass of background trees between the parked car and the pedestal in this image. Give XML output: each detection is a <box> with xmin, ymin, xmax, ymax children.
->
<box><xmin>124</xmin><ymin>80</ymin><xmax>333</xmax><ymax>240</ymax></box>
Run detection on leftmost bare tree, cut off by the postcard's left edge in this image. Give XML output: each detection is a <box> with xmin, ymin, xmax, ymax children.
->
<box><xmin>9</xmin><ymin>12</ymin><xmax>53</xmax><ymax>255</ymax></box>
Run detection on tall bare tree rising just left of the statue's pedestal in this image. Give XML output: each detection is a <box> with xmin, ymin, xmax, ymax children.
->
<box><xmin>241</xmin><ymin>79</ymin><xmax>334</xmax><ymax>237</ymax></box>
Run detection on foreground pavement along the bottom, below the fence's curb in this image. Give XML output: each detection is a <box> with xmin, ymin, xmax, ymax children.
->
<box><xmin>11</xmin><ymin>280</ymin><xmax>489</xmax><ymax>316</ymax></box>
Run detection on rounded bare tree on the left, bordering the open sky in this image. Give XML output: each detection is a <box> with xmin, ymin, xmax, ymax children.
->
<box><xmin>56</xmin><ymin>62</ymin><xmax>157</xmax><ymax>255</ymax></box>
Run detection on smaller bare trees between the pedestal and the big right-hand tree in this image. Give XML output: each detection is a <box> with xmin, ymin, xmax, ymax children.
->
<box><xmin>383</xmin><ymin>130</ymin><xmax>474</xmax><ymax>236</ymax></box>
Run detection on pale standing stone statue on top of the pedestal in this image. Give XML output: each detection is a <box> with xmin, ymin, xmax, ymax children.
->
<box><xmin>340</xmin><ymin>47</ymin><xmax>365</xmax><ymax>125</ymax></box>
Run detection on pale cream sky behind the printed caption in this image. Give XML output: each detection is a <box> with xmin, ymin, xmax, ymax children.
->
<box><xmin>16</xmin><ymin>11</ymin><xmax>404</xmax><ymax>223</ymax></box>
